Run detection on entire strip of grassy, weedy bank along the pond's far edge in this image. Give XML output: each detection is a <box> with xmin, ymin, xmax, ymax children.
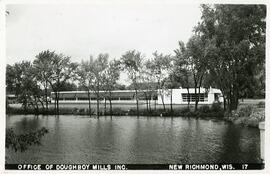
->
<box><xmin>7</xmin><ymin>101</ymin><xmax>265</xmax><ymax>127</ymax></box>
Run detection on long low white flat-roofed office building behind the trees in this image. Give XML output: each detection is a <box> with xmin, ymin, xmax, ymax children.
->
<box><xmin>51</xmin><ymin>88</ymin><xmax>223</xmax><ymax>105</ymax></box>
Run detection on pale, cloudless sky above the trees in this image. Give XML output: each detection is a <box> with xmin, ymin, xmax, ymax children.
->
<box><xmin>6</xmin><ymin>3</ymin><xmax>201</xmax><ymax>64</ymax></box>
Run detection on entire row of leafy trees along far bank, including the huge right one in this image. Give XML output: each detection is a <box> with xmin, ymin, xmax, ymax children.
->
<box><xmin>6</xmin><ymin>5</ymin><xmax>266</xmax><ymax>116</ymax></box>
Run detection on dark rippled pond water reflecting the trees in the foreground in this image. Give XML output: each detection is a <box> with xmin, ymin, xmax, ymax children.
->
<box><xmin>6</xmin><ymin>115</ymin><xmax>260</xmax><ymax>164</ymax></box>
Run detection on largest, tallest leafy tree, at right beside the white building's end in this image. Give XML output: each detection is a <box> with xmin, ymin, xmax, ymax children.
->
<box><xmin>195</xmin><ymin>5</ymin><xmax>266</xmax><ymax>111</ymax></box>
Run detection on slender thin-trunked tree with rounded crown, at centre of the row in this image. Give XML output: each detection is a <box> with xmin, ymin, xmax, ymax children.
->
<box><xmin>121</xmin><ymin>50</ymin><xmax>143</xmax><ymax>116</ymax></box>
